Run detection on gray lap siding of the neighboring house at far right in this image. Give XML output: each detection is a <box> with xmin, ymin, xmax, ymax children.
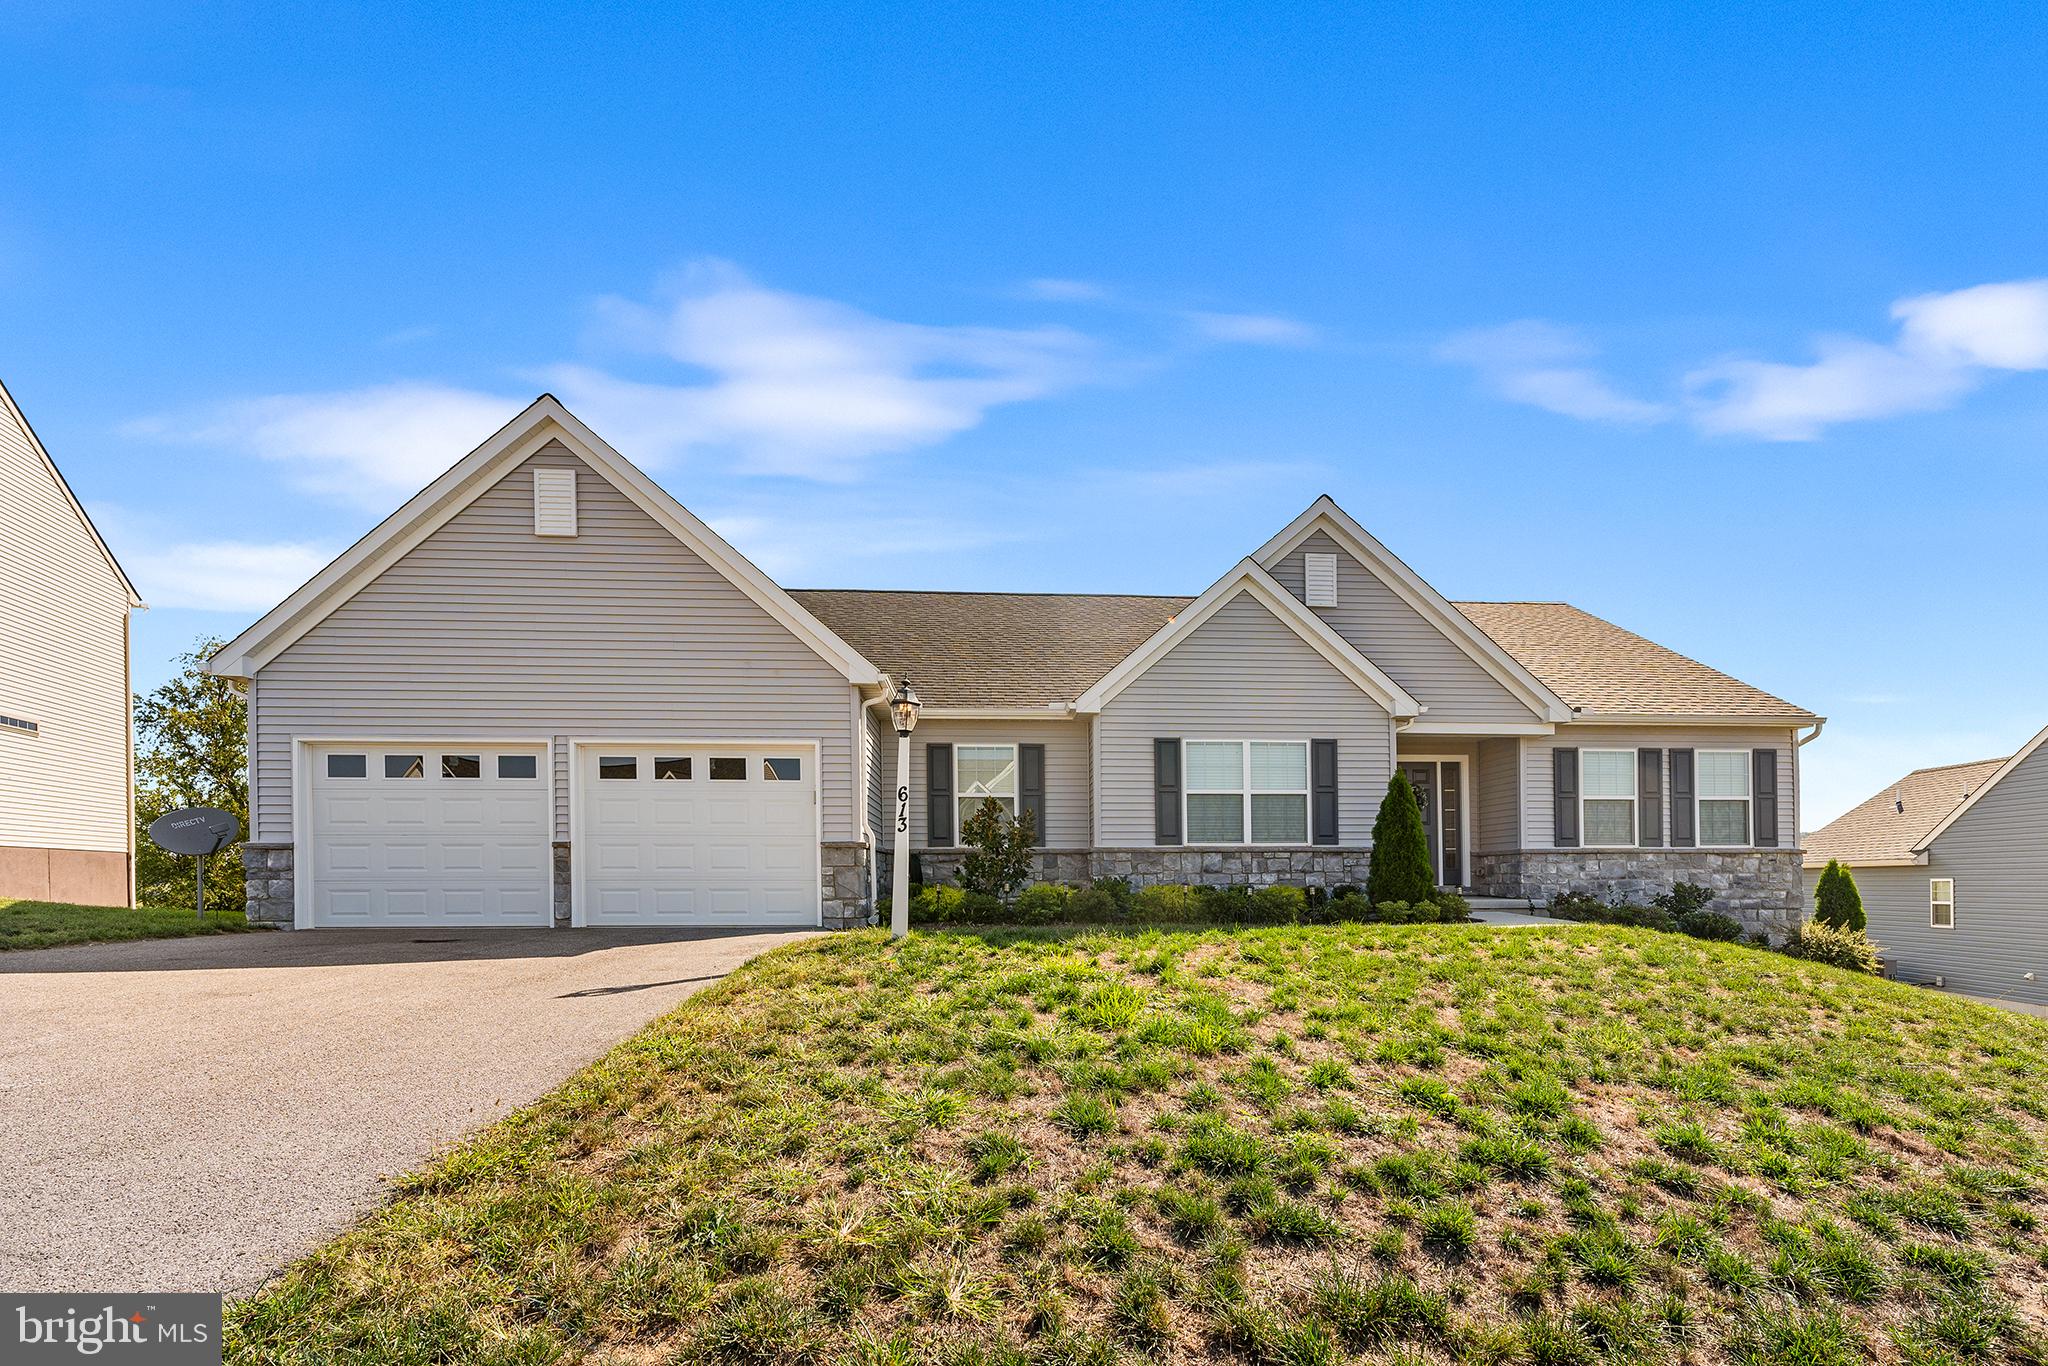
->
<box><xmin>1859</xmin><ymin>748</ymin><xmax>2048</xmax><ymax>1006</ymax></box>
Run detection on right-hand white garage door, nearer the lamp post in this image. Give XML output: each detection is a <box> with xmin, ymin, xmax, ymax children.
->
<box><xmin>573</xmin><ymin>741</ymin><xmax>819</xmax><ymax>926</ymax></box>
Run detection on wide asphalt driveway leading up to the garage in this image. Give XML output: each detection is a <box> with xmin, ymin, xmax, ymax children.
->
<box><xmin>0</xmin><ymin>930</ymin><xmax>803</xmax><ymax>1292</ymax></box>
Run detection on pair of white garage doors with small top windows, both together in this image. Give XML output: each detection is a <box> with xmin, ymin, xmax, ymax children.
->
<box><xmin>297</xmin><ymin>739</ymin><xmax>819</xmax><ymax>928</ymax></box>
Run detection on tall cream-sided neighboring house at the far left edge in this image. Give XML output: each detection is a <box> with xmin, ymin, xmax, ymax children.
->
<box><xmin>0</xmin><ymin>376</ymin><xmax>141</xmax><ymax>905</ymax></box>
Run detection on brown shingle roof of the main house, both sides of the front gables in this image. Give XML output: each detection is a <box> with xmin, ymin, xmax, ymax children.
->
<box><xmin>791</xmin><ymin>588</ymin><xmax>1812</xmax><ymax>721</ymax></box>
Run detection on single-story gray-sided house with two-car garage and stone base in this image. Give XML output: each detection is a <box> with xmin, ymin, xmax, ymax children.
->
<box><xmin>211</xmin><ymin>395</ymin><xmax>1819</xmax><ymax>928</ymax></box>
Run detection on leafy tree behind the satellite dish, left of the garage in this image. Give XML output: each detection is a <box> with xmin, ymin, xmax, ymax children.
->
<box><xmin>135</xmin><ymin>637</ymin><xmax>250</xmax><ymax>911</ymax></box>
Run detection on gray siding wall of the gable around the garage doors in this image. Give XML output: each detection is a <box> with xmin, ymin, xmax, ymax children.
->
<box><xmin>250</xmin><ymin>442</ymin><xmax>858</xmax><ymax>840</ymax></box>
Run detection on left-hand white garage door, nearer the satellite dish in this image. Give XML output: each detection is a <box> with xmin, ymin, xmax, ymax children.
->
<box><xmin>307</xmin><ymin>741</ymin><xmax>555</xmax><ymax>926</ymax></box>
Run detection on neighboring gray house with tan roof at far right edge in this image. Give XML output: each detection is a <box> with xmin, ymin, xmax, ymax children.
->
<box><xmin>1806</xmin><ymin>729</ymin><xmax>2048</xmax><ymax>1006</ymax></box>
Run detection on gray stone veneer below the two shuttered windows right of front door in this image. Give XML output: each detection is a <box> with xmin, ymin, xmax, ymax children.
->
<box><xmin>1473</xmin><ymin>850</ymin><xmax>1806</xmax><ymax>938</ymax></box>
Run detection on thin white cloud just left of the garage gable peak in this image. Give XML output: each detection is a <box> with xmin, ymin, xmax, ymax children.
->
<box><xmin>125</xmin><ymin>383</ymin><xmax>524</xmax><ymax>508</ymax></box>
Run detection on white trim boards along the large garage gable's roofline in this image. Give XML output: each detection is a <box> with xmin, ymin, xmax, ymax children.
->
<box><xmin>207</xmin><ymin>393</ymin><xmax>883</xmax><ymax>688</ymax></box>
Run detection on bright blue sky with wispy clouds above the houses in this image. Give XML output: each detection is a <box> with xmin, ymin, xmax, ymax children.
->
<box><xmin>0</xmin><ymin>0</ymin><xmax>2048</xmax><ymax>825</ymax></box>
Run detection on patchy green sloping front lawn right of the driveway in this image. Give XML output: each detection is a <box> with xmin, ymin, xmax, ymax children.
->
<box><xmin>229</xmin><ymin>926</ymin><xmax>2048</xmax><ymax>1366</ymax></box>
